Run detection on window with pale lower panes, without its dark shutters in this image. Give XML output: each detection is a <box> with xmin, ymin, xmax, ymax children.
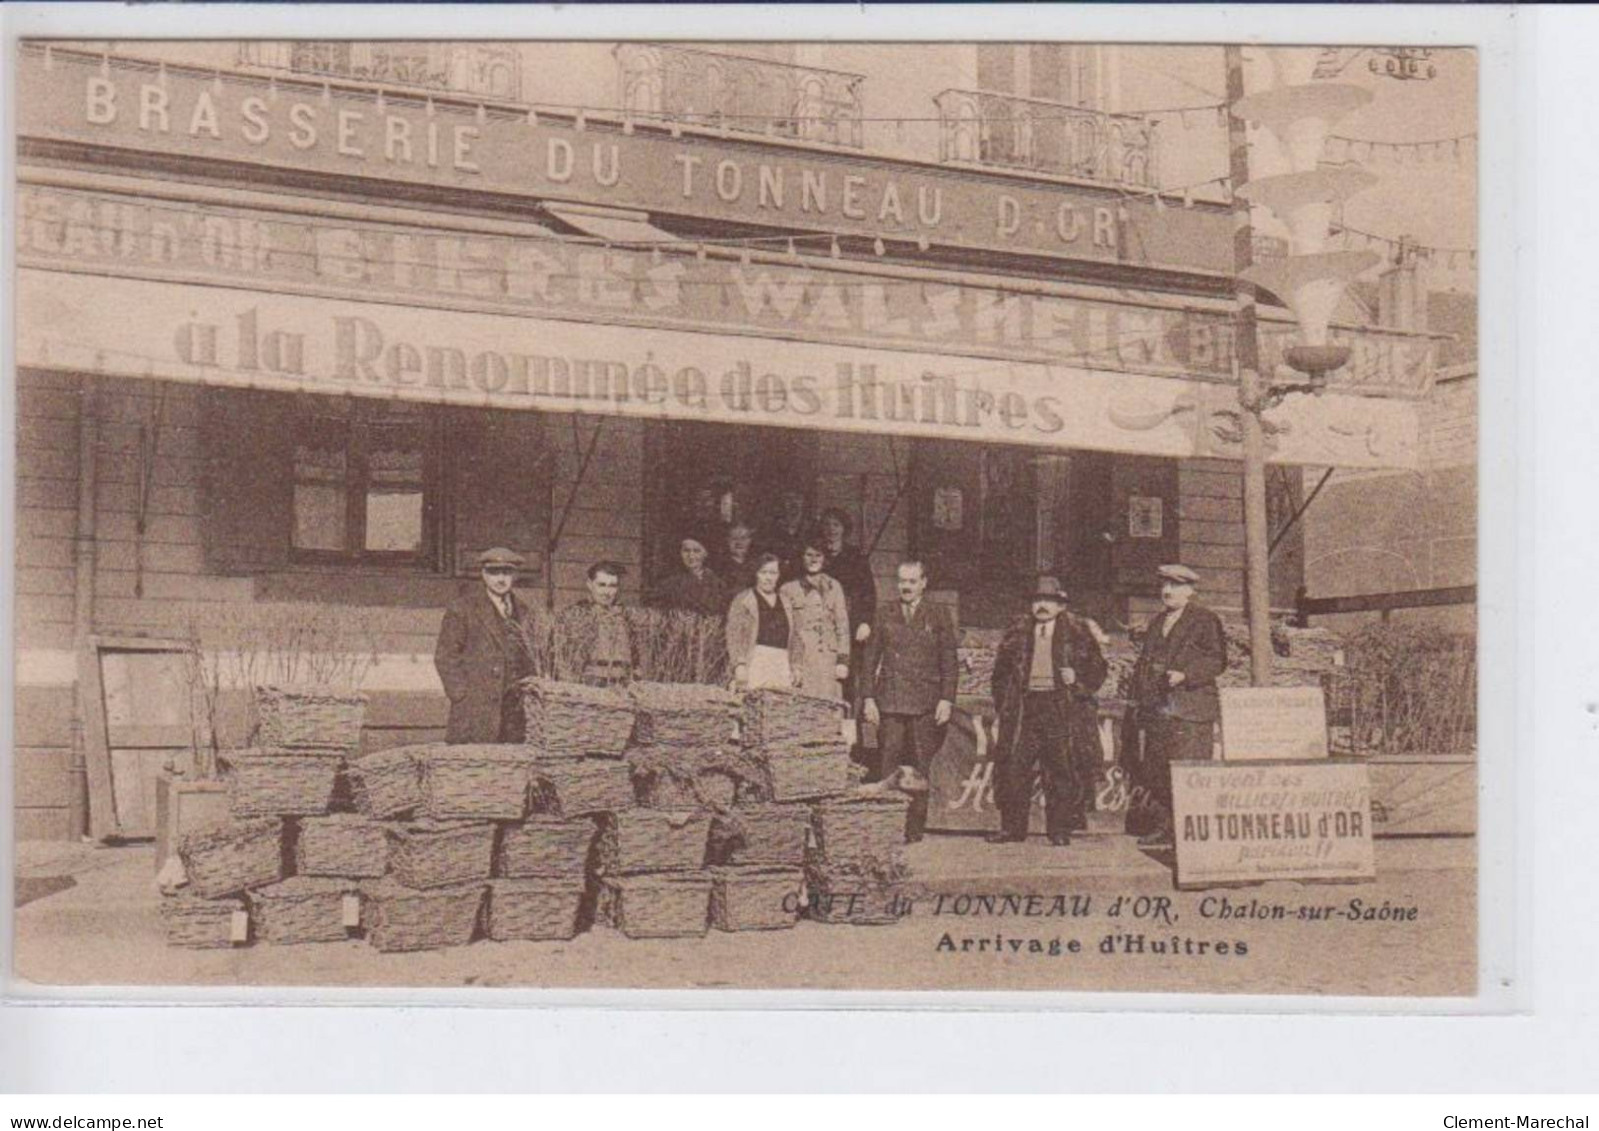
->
<box><xmin>291</xmin><ymin>402</ymin><xmax>437</xmax><ymax>563</ymax></box>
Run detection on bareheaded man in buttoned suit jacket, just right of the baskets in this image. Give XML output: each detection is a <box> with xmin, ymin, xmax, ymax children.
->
<box><xmin>860</xmin><ymin>562</ymin><xmax>958</xmax><ymax>841</ymax></box>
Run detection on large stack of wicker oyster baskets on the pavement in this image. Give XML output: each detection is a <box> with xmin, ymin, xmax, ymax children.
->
<box><xmin>161</xmin><ymin>681</ymin><xmax>907</xmax><ymax>950</ymax></box>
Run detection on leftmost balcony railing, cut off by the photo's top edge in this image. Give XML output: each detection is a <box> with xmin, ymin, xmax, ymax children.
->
<box><xmin>238</xmin><ymin>40</ymin><xmax>521</xmax><ymax>101</ymax></box>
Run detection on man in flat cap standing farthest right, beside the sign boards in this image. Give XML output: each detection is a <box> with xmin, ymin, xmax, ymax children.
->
<box><xmin>1129</xmin><ymin>565</ymin><xmax>1226</xmax><ymax>845</ymax></box>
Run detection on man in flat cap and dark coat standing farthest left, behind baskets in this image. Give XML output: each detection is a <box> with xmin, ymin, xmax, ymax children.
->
<box><xmin>433</xmin><ymin>546</ymin><xmax>532</xmax><ymax>742</ymax></box>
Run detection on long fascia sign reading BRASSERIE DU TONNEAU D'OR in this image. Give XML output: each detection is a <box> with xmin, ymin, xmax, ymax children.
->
<box><xmin>18</xmin><ymin>46</ymin><xmax>1233</xmax><ymax>274</ymax></box>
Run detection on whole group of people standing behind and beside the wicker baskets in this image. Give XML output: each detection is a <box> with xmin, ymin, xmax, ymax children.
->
<box><xmin>435</xmin><ymin>531</ymin><xmax>1226</xmax><ymax>845</ymax></box>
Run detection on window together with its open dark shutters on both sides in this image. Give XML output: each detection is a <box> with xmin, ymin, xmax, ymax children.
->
<box><xmin>200</xmin><ymin>389</ymin><xmax>552</xmax><ymax>584</ymax></box>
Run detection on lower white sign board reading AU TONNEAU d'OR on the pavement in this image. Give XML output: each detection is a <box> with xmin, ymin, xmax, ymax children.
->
<box><xmin>1172</xmin><ymin>761</ymin><xmax>1377</xmax><ymax>888</ymax></box>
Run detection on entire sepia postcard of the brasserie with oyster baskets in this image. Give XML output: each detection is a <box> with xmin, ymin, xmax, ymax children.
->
<box><xmin>8</xmin><ymin>26</ymin><xmax>1482</xmax><ymax>1000</ymax></box>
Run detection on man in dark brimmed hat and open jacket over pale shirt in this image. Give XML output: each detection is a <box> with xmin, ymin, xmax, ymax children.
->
<box><xmin>988</xmin><ymin>576</ymin><xmax>1107</xmax><ymax>845</ymax></box>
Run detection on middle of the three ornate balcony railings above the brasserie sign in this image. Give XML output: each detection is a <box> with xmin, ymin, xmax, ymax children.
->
<box><xmin>616</xmin><ymin>43</ymin><xmax>865</xmax><ymax>149</ymax></box>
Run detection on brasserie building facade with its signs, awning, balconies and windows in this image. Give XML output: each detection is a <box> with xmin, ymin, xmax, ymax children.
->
<box><xmin>16</xmin><ymin>42</ymin><xmax>1464</xmax><ymax>870</ymax></box>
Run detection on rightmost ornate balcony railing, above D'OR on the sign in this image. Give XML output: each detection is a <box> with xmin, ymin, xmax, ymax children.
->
<box><xmin>934</xmin><ymin>90</ymin><xmax>1156</xmax><ymax>189</ymax></box>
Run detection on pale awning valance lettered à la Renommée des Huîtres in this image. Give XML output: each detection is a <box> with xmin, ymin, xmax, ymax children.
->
<box><xmin>18</xmin><ymin>267</ymin><xmax>1417</xmax><ymax>467</ymax></box>
